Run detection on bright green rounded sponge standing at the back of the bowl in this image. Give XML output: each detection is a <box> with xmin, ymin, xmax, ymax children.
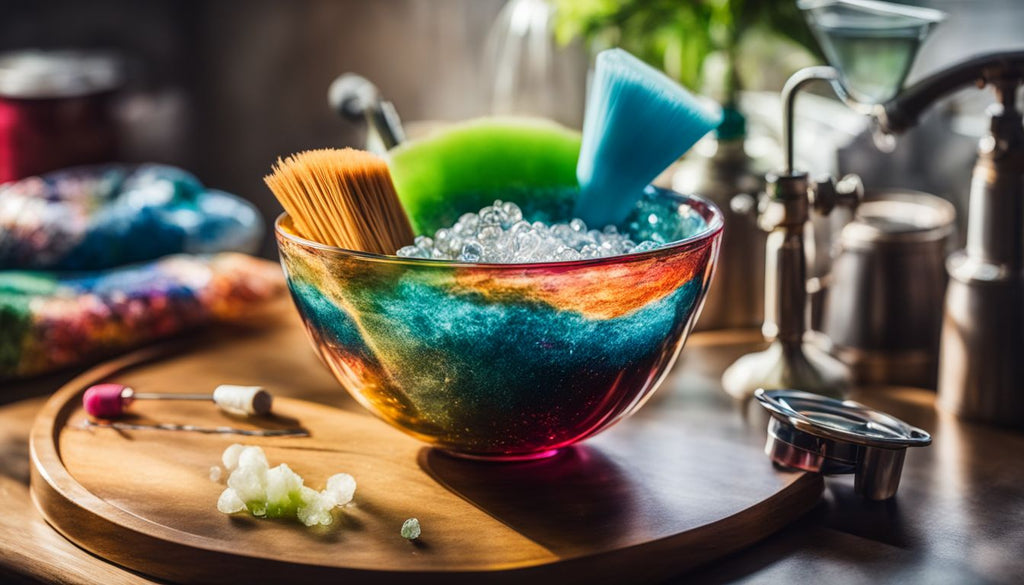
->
<box><xmin>388</xmin><ymin>118</ymin><xmax>581</xmax><ymax>235</ymax></box>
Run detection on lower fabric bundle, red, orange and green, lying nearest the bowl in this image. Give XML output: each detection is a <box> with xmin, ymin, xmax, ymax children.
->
<box><xmin>0</xmin><ymin>253</ymin><xmax>284</xmax><ymax>378</ymax></box>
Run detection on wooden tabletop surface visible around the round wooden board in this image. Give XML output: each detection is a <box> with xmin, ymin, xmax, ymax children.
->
<box><xmin>0</xmin><ymin>303</ymin><xmax>1024</xmax><ymax>584</ymax></box>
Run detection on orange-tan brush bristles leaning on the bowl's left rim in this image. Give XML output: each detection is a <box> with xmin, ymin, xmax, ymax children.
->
<box><xmin>263</xmin><ymin>149</ymin><xmax>413</xmax><ymax>254</ymax></box>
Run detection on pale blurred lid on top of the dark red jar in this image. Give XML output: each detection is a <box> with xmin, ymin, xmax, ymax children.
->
<box><xmin>0</xmin><ymin>50</ymin><xmax>122</xmax><ymax>99</ymax></box>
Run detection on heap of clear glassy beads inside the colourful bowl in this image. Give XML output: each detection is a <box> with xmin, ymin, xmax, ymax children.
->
<box><xmin>397</xmin><ymin>200</ymin><xmax>658</xmax><ymax>263</ymax></box>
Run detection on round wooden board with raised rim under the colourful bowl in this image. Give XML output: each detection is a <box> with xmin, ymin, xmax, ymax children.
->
<box><xmin>31</xmin><ymin>309</ymin><xmax>822</xmax><ymax>583</ymax></box>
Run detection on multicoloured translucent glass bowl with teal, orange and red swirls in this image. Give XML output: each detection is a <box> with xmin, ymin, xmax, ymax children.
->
<box><xmin>275</xmin><ymin>190</ymin><xmax>722</xmax><ymax>459</ymax></box>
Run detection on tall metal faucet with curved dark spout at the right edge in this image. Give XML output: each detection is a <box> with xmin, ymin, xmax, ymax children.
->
<box><xmin>874</xmin><ymin>51</ymin><xmax>1024</xmax><ymax>427</ymax></box>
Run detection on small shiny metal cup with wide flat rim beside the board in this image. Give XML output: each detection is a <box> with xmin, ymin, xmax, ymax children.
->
<box><xmin>754</xmin><ymin>389</ymin><xmax>932</xmax><ymax>500</ymax></box>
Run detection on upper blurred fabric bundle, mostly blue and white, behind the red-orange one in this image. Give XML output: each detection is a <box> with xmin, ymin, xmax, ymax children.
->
<box><xmin>0</xmin><ymin>164</ymin><xmax>263</xmax><ymax>270</ymax></box>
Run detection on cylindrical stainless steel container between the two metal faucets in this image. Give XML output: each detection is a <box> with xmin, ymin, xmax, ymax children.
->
<box><xmin>822</xmin><ymin>191</ymin><xmax>955</xmax><ymax>388</ymax></box>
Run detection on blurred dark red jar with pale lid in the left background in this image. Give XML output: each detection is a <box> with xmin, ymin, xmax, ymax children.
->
<box><xmin>0</xmin><ymin>51</ymin><xmax>122</xmax><ymax>182</ymax></box>
